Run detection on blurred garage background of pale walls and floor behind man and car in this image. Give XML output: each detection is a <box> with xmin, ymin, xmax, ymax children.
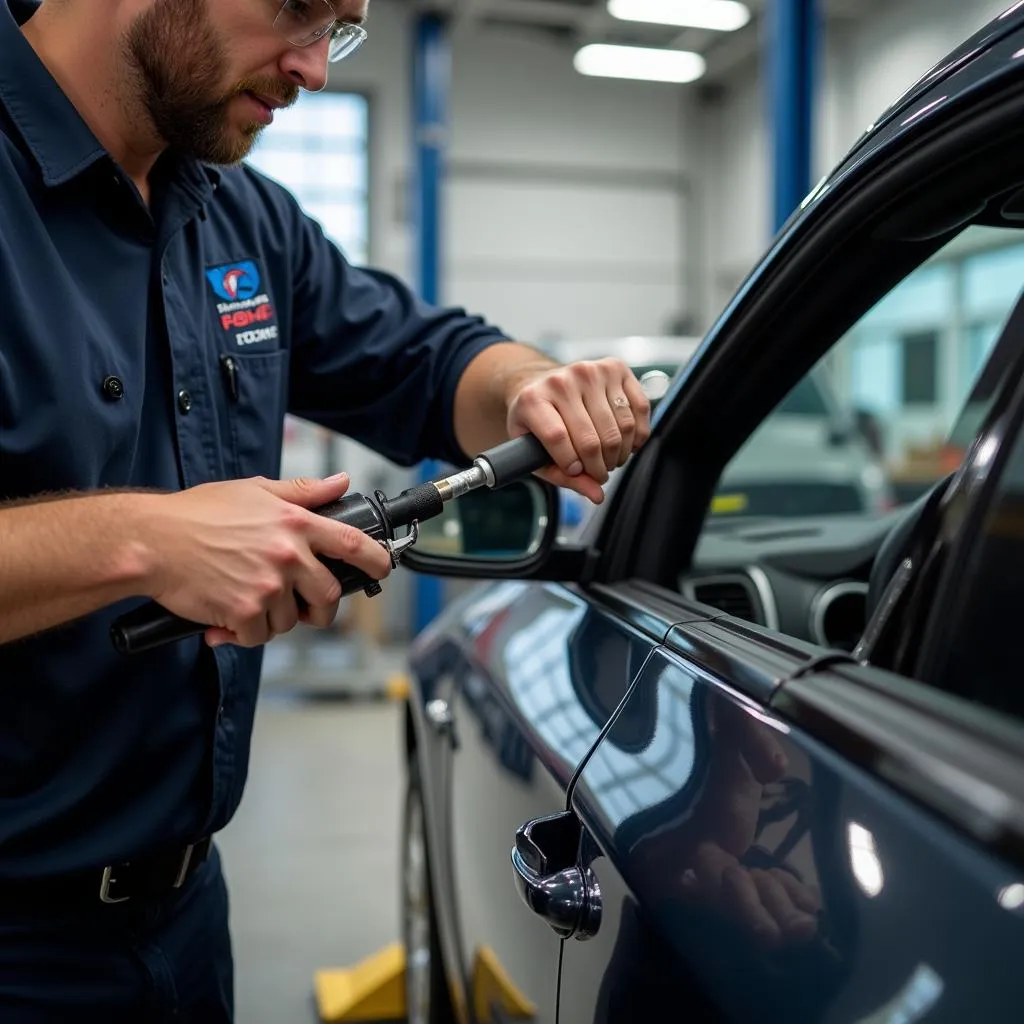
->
<box><xmin>6</xmin><ymin>0</ymin><xmax>1009</xmax><ymax>1024</ymax></box>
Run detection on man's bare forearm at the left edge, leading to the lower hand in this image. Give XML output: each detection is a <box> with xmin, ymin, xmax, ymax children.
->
<box><xmin>0</xmin><ymin>493</ymin><xmax>154</xmax><ymax>643</ymax></box>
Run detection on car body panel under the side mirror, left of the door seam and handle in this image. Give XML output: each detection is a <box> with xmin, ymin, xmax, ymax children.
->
<box><xmin>421</xmin><ymin>583</ymin><xmax>708</xmax><ymax>1024</ymax></box>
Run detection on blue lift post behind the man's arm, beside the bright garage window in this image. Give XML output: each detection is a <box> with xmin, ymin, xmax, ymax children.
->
<box><xmin>413</xmin><ymin>14</ymin><xmax>452</xmax><ymax>633</ymax></box>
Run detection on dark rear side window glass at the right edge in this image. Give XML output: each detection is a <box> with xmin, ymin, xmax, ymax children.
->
<box><xmin>936</xmin><ymin>413</ymin><xmax>1024</xmax><ymax>718</ymax></box>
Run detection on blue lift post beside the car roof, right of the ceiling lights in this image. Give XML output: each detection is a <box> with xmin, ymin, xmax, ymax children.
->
<box><xmin>768</xmin><ymin>0</ymin><xmax>818</xmax><ymax>231</ymax></box>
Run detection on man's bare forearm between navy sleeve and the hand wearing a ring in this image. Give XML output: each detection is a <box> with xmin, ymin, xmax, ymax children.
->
<box><xmin>455</xmin><ymin>342</ymin><xmax>559</xmax><ymax>458</ymax></box>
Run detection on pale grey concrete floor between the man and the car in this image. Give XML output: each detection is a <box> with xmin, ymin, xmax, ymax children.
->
<box><xmin>218</xmin><ymin>638</ymin><xmax>403</xmax><ymax>1024</ymax></box>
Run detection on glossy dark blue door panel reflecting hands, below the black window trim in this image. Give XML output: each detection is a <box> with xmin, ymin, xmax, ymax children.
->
<box><xmin>561</xmin><ymin>651</ymin><xmax>1024</xmax><ymax>1024</ymax></box>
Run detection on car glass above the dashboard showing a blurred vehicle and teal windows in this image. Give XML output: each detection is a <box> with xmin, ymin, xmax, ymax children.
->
<box><xmin>697</xmin><ymin>226</ymin><xmax>1024</xmax><ymax>528</ymax></box>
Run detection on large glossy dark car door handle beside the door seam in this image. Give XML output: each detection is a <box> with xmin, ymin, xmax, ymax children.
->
<box><xmin>512</xmin><ymin>811</ymin><xmax>601</xmax><ymax>940</ymax></box>
